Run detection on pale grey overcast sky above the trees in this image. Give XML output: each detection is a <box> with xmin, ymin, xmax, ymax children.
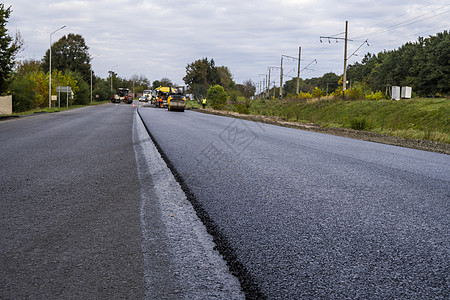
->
<box><xmin>4</xmin><ymin>0</ymin><xmax>450</xmax><ymax>85</ymax></box>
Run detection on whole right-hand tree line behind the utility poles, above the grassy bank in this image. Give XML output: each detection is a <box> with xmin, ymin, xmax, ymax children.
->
<box><xmin>283</xmin><ymin>31</ymin><xmax>450</xmax><ymax>98</ymax></box>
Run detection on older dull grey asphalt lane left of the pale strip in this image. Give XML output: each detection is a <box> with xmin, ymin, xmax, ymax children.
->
<box><xmin>0</xmin><ymin>105</ymin><xmax>144</xmax><ymax>299</ymax></box>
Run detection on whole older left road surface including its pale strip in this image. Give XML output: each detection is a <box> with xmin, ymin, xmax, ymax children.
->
<box><xmin>0</xmin><ymin>104</ymin><xmax>243</xmax><ymax>299</ymax></box>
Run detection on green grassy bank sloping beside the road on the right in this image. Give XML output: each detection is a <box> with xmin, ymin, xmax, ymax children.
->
<box><xmin>249</xmin><ymin>98</ymin><xmax>450</xmax><ymax>143</ymax></box>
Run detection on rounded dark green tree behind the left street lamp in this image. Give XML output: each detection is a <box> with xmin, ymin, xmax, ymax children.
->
<box><xmin>42</xmin><ymin>33</ymin><xmax>91</xmax><ymax>82</ymax></box>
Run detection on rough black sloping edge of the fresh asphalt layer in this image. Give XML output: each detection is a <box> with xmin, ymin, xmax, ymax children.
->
<box><xmin>137</xmin><ymin>109</ymin><xmax>267</xmax><ymax>299</ymax></box>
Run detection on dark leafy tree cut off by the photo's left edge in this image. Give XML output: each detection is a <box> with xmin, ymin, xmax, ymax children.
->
<box><xmin>0</xmin><ymin>3</ymin><xmax>23</xmax><ymax>95</ymax></box>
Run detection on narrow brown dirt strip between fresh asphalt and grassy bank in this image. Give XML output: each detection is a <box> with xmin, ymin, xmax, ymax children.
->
<box><xmin>195</xmin><ymin>109</ymin><xmax>450</xmax><ymax>154</ymax></box>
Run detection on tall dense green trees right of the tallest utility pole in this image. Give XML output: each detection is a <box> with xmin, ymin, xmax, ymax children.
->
<box><xmin>347</xmin><ymin>31</ymin><xmax>450</xmax><ymax>96</ymax></box>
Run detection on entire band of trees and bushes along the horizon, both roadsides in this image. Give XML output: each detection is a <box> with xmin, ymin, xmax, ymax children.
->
<box><xmin>0</xmin><ymin>4</ymin><xmax>450</xmax><ymax>112</ymax></box>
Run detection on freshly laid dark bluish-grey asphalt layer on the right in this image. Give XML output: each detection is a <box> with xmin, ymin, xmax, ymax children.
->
<box><xmin>138</xmin><ymin>107</ymin><xmax>450</xmax><ymax>299</ymax></box>
